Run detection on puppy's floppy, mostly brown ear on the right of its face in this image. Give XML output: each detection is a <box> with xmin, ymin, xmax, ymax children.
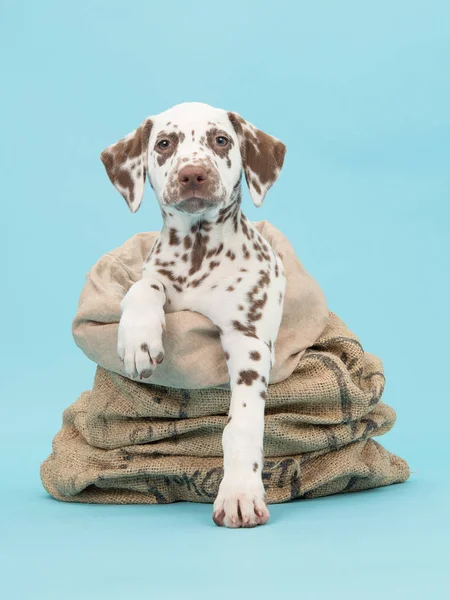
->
<box><xmin>228</xmin><ymin>112</ymin><xmax>286</xmax><ymax>206</ymax></box>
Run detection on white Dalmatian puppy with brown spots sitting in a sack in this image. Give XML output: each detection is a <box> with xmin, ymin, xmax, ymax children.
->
<box><xmin>102</xmin><ymin>103</ymin><xmax>286</xmax><ymax>527</ymax></box>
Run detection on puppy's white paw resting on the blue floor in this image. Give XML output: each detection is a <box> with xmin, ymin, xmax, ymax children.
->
<box><xmin>213</xmin><ymin>475</ymin><xmax>270</xmax><ymax>528</ymax></box>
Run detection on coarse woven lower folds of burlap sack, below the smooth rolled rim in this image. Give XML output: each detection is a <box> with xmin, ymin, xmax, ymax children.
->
<box><xmin>41</xmin><ymin>313</ymin><xmax>409</xmax><ymax>504</ymax></box>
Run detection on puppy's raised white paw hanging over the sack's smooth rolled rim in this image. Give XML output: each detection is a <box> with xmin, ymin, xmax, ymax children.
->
<box><xmin>117</xmin><ymin>309</ymin><xmax>166</xmax><ymax>379</ymax></box>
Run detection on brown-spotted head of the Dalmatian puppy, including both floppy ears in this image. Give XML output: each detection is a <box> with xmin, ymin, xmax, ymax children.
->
<box><xmin>101</xmin><ymin>102</ymin><xmax>286</xmax><ymax>214</ymax></box>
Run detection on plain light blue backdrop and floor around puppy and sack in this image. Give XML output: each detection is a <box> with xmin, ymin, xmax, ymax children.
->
<box><xmin>0</xmin><ymin>0</ymin><xmax>450</xmax><ymax>600</ymax></box>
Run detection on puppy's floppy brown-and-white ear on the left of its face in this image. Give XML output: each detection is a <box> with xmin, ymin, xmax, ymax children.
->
<box><xmin>100</xmin><ymin>118</ymin><xmax>152</xmax><ymax>213</ymax></box>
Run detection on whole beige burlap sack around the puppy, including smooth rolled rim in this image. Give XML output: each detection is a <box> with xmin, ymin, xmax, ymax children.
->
<box><xmin>41</xmin><ymin>221</ymin><xmax>409</xmax><ymax>504</ymax></box>
